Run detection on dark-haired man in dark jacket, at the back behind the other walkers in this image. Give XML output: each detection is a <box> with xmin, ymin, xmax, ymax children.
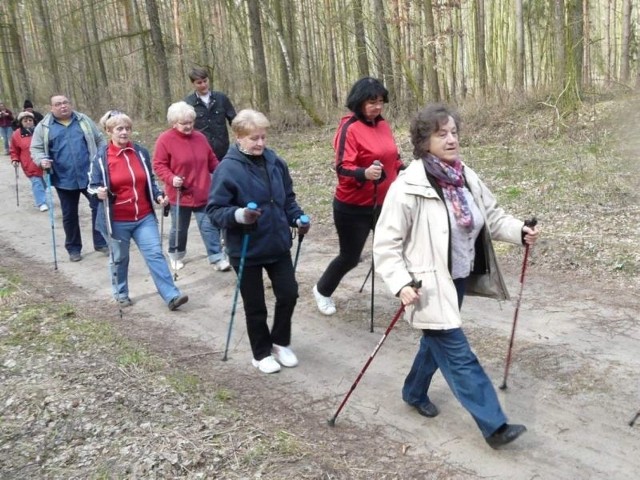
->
<box><xmin>184</xmin><ymin>67</ymin><xmax>236</xmax><ymax>160</ymax></box>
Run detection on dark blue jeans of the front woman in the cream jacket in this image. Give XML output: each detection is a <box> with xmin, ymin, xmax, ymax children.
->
<box><xmin>402</xmin><ymin>279</ymin><xmax>507</xmax><ymax>438</ymax></box>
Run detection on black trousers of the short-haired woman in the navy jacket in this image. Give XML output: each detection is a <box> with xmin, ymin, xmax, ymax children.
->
<box><xmin>238</xmin><ymin>254</ymin><xmax>298</xmax><ymax>360</ymax></box>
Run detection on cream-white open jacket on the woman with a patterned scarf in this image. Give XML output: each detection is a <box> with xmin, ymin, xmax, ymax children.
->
<box><xmin>373</xmin><ymin>160</ymin><xmax>524</xmax><ymax>330</ymax></box>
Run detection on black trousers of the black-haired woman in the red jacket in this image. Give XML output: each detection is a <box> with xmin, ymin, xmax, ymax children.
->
<box><xmin>317</xmin><ymin>208</ymin><xmax>373</xmax><ymax>297</ymax></box>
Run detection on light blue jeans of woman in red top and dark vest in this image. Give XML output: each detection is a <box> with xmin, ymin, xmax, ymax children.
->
<box><xmin>109</xmin><ymin>213</ymin><xmax>180</xmax><ymax>304</ymax></box>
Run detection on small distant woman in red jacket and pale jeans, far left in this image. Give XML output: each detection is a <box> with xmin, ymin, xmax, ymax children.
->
<box><xmin>9</xmin><ymin>112</ymin><xmax>49</xmax><ymax>212</ymax></box>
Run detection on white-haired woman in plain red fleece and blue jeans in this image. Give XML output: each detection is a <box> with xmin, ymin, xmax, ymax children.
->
<box><xmin>153</xmin><ymin>102</ymin><xmax>231</xmax><ymax>272</ymax></box>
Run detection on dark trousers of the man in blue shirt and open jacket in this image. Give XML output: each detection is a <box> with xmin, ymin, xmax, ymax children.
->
<box><xmin>56</xmin><ymin>188</ymin><xmax>107</xmax><ymax>254</ymax></box>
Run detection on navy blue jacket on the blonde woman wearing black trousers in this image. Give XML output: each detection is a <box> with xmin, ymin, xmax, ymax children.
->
<box><xmin>206</xmin><ymin>145</ymin><xmax>304</xmax><ymax>266</ymax></box>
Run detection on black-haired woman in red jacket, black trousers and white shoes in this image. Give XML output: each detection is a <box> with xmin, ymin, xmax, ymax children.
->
<box><xmin>313</xmin><ymin>77</ymin><xmax>403</xmax><ymax>315</ymax></box>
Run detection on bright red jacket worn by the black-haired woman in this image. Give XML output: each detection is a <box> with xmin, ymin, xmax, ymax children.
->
<box><xmin>333</xmin><ymin>114</ymin><xmax>403</xmax><ymax>208</ymax></box>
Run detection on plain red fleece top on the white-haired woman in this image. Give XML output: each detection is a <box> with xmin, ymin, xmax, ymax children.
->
<box><xmin>153</xmin><ymin>128</ymin><xmax>218</xmax><ymax>208</ymax></box>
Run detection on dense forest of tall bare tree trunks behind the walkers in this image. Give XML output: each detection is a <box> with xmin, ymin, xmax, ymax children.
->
<box><xmin>0</xmin><ymin>0</ymin><xmax>640</xmax><ymax>126</ymax></box>
